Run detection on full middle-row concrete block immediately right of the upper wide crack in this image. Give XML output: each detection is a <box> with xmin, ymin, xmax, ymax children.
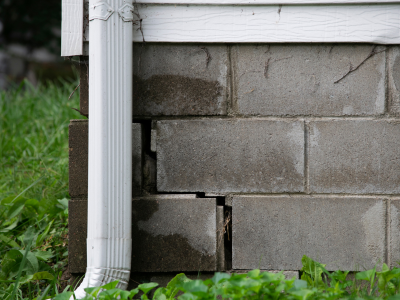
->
<box><xmin>157</xmin><ymin>119</ymin><xmax>304</xmax><ymax>193</ymax></box>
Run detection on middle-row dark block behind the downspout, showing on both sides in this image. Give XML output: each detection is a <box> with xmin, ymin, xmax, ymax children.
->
<box><xmin>69</xmin><ymin>120</ymin><xmax>143</xmax><ymax>198</ymax></box>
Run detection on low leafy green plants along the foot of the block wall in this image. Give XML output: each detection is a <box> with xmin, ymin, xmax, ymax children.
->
<box><xmin>49</xmin><ymin>256</ymin><xmax>400</xmax><ymax>300</ymax></box>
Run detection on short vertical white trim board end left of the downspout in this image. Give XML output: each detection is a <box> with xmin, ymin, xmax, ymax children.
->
<box><xmin>61</xmin><ymin>0</ymin><xmax>83</xmax><ymax>56</ymax></box>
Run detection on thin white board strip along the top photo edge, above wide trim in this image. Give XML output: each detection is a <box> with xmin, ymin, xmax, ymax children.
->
<box><xmin>136</xmin><ymin>0</ymin><xmax>400</xmax><ymax>5</ymax></box>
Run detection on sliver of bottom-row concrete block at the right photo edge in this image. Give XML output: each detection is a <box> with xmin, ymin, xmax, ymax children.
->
<box><xmin>389</xmin><ymin>199</ymin><xmax>400</xmax><ymax>268</ymax></box>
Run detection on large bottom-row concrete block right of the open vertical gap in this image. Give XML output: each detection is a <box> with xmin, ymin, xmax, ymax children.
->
<box><xmin>232</xmin><ymin>195</ymin><xmax>386</xmax><ymax>271</ymax></box>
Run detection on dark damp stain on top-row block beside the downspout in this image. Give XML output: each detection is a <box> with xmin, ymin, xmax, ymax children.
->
<box><xmin>133</xmin><ymin>75</ymin><xmax>223</xmax><ymax>116</ymax></box>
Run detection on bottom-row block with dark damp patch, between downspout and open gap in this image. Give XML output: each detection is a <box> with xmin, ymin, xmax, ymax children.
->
<box><xmin>132</xmin><ymin>196</ymin><xmax>218</xmax><ymax>272</ymax></box>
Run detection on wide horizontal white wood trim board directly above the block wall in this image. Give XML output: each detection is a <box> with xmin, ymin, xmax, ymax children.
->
<box><xmin>133</xmin><ymin>4</ymin><xmax>400</xmax><ymax>44</ymax></box>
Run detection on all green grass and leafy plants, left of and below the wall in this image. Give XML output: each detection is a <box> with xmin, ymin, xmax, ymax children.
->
<box><xmin>0</xmin><ymin>81</ymin><xmax>400</xmax><ymax>300</ymax></box>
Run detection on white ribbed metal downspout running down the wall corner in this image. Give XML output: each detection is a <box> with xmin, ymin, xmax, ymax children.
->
<box><xmin>75</xmin><ymin>0</ymin><xmax>133</xmax><ymax>299</ymax></box>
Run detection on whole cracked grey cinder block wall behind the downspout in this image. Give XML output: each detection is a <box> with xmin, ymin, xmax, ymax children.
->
<box><xmin>69</xmin><ymin>43</ymin><xmax>400</xmax><ymax>278</ymax></box>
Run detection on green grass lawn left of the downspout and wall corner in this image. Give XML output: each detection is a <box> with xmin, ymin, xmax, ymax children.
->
<box><xmin>0</xmin><ymin>80</ymin><xmax>82</xmax><ymax>300</ymax></box>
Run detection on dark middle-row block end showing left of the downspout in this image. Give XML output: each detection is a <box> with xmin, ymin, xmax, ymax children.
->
<box><xmin>69</xmin><ymin>120</ymin><xmax>89</xmax><ymax>197</ymax></box>
